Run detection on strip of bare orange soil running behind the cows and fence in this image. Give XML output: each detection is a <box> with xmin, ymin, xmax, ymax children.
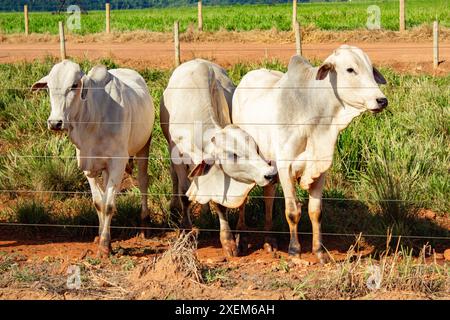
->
<box><xmin>0</xmin><ymin>33</ymin><xmax>450</xmax><ymax>76</ymax></box>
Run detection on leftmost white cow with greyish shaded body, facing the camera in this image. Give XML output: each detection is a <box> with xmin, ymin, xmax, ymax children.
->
<box><xmin>32</xmin><ymin>60</ymin><xmax>155</xmax><ymax>256</ymax></box>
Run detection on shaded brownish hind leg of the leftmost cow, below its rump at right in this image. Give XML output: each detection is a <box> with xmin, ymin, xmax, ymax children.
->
<box><xmin>136</xmin><ymin>137</ymin><xmax>151</xmax><ymax>238</ymax></box>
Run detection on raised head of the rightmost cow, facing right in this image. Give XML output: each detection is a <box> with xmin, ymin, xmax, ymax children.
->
<box><xmin>316</xmin><ymin>45</ymin><xmax>388</xmax><ymax>113</ymax></box>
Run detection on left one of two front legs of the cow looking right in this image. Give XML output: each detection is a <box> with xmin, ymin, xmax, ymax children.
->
<box><xmin>278</xmin><ymin>168</ymin><xmax>301</xmax><ymax>256</ymax></box>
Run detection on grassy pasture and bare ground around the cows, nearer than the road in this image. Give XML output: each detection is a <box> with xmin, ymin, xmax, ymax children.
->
<box><xmin>0</xmin><ymin>58</ymin><xmax>450</xmax><ymax>299</ymax></box>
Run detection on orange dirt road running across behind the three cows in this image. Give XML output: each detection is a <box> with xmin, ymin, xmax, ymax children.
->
<box><xmin>0</xmin><ymin>42</ymin><xmax>450</xmax><ymax>75</ymax></box>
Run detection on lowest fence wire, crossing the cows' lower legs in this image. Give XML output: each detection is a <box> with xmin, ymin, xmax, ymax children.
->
<box><xmin>0</xmin><ymin>222</ymin><xmax>450</xmax><ymax>240</ymax></box>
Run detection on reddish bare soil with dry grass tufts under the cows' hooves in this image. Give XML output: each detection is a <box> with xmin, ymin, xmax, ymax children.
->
<box><xmin>0</xmin><ymin>228</ymin><xmax>450</xmax><ymax>300</ymax></box>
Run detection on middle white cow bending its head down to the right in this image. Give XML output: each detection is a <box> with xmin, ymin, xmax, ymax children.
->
<box><xmin>161</xmin><ymin>59</ymin><xmax>276</xmax><ymax>255</ymax></box>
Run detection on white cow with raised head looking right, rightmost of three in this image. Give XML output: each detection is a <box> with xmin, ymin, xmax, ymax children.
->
<box><xmin>232</xmin><ymin>45</ymin><xmax>388</xmax><ymax>262</ymax></box>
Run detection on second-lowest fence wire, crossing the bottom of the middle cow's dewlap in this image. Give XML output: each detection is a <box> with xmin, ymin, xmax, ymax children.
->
<box><xmin>0</xmin><ymin>189</ymin><xmax>432</xmax><ymax>203</ymax></box>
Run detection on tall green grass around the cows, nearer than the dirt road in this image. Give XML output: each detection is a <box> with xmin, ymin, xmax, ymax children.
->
<box><xmin>0</xmin><ymin>59</ymin><xmax>450</xmax><ymax>249</ymax></box>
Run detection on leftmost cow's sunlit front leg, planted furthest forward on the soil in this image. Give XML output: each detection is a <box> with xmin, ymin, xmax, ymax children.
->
<box><xmin>98</xmin><ymin>160</ymin><xmax>127</xmax><ymax>257</ymax></box>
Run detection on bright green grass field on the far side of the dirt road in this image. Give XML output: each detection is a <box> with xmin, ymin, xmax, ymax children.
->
<box><xmin>0</xmin><ymin>0</ymin><xmax>450</xmax><ymax>34</ymax></box>
